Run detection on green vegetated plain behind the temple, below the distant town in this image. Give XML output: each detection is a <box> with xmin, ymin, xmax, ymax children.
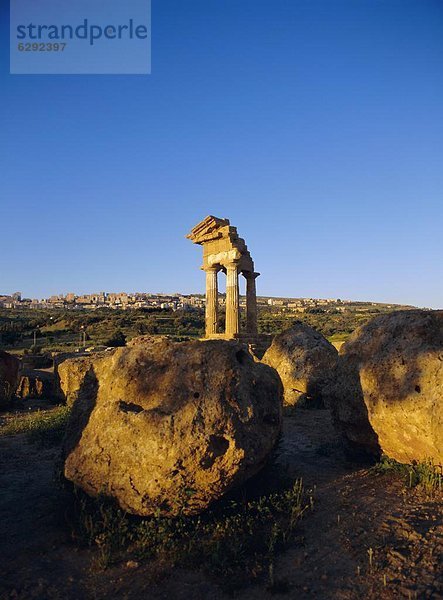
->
<box><xmin>0</xmin><ymin>305</ymin><xmax>393</xmax><ymax>353</ymax></box>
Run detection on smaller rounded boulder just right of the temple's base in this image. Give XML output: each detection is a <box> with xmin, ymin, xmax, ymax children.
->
<box><xmin>262</xmin><ymin>322</ymin><xmax>338</xmax><ymax>408</ymax></box>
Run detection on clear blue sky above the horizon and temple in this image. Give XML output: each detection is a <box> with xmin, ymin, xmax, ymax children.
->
<box><xmin>0</xmin><ymin>0</ymin><xmax>443</xmax><ymax>308</ymax></box>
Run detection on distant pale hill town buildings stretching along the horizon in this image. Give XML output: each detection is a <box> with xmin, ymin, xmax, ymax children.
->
<box><xmin>0</xmin><ymin>292</ymin><xmax>414</xmax><ymax>313</ymax></box>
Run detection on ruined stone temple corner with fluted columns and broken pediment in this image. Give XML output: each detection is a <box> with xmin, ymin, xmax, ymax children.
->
<box><xmin>186</xmin><ymin>216</ymin><xmax>262</xmax><ymax>344</ymax></box>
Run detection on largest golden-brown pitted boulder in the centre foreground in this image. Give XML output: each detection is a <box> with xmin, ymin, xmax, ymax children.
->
<box><xmin>64</xmin><ymin>339</ymin><xmax>282</xmax><ymax>515</ymax></box>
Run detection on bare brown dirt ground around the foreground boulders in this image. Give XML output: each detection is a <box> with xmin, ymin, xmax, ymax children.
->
<box><xmin>0</xmin><ymin>410</ymin><xmax>443</xmax><ymax>600</ymax></box>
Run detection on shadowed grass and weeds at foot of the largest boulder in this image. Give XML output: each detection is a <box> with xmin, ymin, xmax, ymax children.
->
<box><xmin>70</xmin><ymin>480</ymin><xmax>313</xmax><ymax>591</ymax></box>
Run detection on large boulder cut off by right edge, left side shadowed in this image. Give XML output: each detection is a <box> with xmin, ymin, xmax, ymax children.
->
<box><xmin>331</xmin><ymin>310</ymin><xmax>443</xmax><ymax>464</ymax></box>
